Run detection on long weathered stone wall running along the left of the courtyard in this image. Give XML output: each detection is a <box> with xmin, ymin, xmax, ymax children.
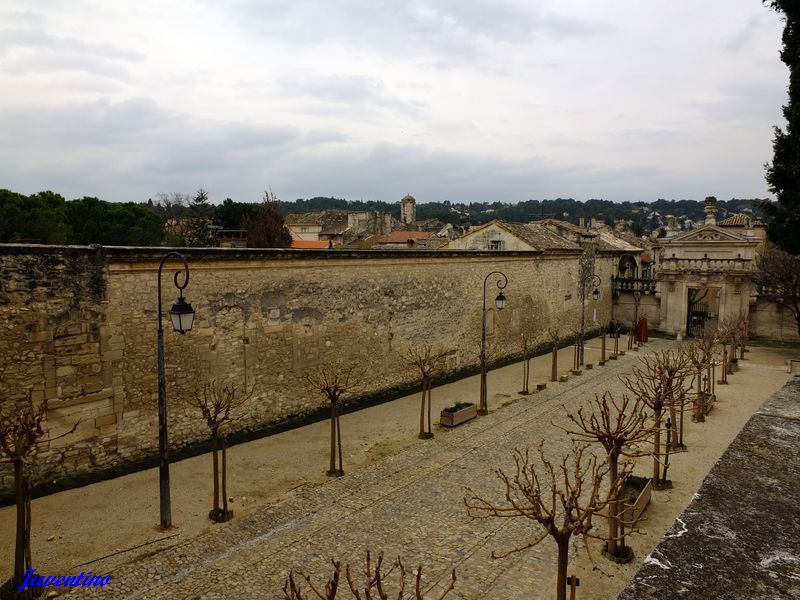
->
<box><xmin>0</xmin><ymin>246</ymin><xmax>617</xmax><ymax>491</ymax></box>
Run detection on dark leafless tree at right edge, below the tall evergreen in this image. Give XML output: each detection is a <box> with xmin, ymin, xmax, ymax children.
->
<box><xmin>753</xmin><ymin>247</ymin><xmax>800</xmax><ymax>335</ymax></box>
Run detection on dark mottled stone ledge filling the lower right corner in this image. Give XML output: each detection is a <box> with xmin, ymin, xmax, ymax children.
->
<box><xmin>619</xmin><ymin>375</ymin><xmax>800</xmax><ymax>600</ymax></box>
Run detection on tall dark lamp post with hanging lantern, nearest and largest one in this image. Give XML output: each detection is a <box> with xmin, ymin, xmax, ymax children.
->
<box><xmin>157</xmin><ymin>252</ymin><xmax>194</xmax><ymax>529</ymax></box>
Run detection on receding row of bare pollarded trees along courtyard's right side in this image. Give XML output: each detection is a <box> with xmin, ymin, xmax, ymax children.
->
<box><xmin>464</xmin><ymin>318</ymin><xmax>747</xmax><ymax>600</ymax></box>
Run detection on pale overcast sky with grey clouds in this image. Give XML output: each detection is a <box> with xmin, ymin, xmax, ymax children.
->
<box><xmin>0</xmin><ymin>0</ymin><xmax>788</xmax><ymax>202</ymax></box>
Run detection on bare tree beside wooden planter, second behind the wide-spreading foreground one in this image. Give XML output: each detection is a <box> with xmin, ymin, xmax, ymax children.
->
<box><xmin>559</xmin><ymin>392</ymin><xmax>652</xmax><ymax>557</ymax></box>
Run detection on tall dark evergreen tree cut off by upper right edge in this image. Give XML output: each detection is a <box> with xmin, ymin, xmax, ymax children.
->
<box><xmin>763</xmin><ymin>0</ymin><xmax>800</xmax><ymax>254</ymax></box>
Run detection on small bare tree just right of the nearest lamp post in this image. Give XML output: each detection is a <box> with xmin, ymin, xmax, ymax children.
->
<box><xmin>186</xmin><ymin>381</ymin><xmax>253</xmax><ymax>523</ymax></box>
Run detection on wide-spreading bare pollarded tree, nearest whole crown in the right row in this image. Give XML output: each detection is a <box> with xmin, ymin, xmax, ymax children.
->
<box><xmin>464</xmin><ymin>442</ymin><xmax>629</xmax><ymax>600</ymax></box>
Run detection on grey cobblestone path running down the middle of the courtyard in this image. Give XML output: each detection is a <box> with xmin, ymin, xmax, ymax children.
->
<box><xmin>73</xmin><ymin>340</ymin><xmax>670</xmax><ymax>600</ymax></box>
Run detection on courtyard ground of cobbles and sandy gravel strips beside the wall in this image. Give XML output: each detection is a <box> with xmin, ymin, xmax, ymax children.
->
<box><xmin>0</xmin><ymin>339</ymin><xmax>796</xmax><ymax>599</ymax></box>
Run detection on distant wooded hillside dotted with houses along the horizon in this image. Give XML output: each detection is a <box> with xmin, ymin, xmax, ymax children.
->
<box><xmin>281</xmin><ymin>197</ymin><xmax>762</xmax><ymax>235</ymax></box>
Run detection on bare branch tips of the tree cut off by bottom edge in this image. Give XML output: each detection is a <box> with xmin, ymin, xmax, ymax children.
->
<box><xmin>283</xmin><ymin>550</ymin><xmax>456</xmax><ymax>600</ymax></box>
